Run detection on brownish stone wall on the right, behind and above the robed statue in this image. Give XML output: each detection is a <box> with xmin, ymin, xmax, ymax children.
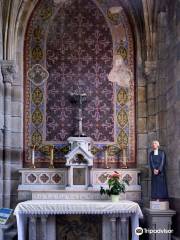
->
<box><xmin>143</xmin><ymin>1</ymin><xmax>180</xmax><ymax>237</ymax></box>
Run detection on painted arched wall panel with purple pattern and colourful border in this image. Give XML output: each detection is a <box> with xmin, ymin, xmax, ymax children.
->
<box><xmin>24</xmin><ymin>0</ymin><xmax>138</xmax><ymax>167</ymax></box>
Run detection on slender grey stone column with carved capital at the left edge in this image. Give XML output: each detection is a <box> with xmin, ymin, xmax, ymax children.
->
<box><xmin>1</xmin><ymin>61</ymin><xmax>16</xmax><ymax>207</ymax></box>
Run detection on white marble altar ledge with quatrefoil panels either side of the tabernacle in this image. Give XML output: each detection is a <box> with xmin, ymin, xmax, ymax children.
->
<box><xmin>18</xmin><ymin>168</ymin><xmax>141</xmax><ymax>202</ymax></box>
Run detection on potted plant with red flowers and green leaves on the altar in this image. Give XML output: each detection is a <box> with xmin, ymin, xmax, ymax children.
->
<box><xmin>100</xmin><ymin>171</ymin><xmax>129</xmax><ymax>196</ymax></box>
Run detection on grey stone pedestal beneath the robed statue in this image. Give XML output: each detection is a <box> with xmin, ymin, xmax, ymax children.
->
<box><xmin>144</xmin><ymin>208</ymin><xmax>176</xmax><ymax>240</ymax></box>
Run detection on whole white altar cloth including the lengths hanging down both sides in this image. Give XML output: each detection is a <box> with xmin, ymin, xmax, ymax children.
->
<box><xmin>14</xmin><ymin>200</ymin><xmax>143</xmax><ymax>240</ymax></box>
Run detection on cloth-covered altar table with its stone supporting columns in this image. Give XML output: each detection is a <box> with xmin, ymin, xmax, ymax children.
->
<box><xmin>14</xmin><ymin>200</ymin><xmax>143</xmax><ymax>240</ymax></box>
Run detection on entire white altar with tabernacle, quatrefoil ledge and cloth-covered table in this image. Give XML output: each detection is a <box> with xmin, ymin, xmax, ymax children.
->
<box><xmin>15</xmin><ymin>137</ymin><xmax>142</xmax><ymax>240</ymax></box>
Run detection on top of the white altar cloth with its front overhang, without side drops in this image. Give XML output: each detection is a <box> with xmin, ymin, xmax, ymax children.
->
<box><xmin>14</xmin><ymin>200</ymin><xmax>142</xmax><ymax>217</ymax></box>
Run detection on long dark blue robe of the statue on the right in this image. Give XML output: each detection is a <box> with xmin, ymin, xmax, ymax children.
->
<box><xmin>149</xmin><ymin>150</ymin><xmax>168</xmax><ymax>200</ymax></box>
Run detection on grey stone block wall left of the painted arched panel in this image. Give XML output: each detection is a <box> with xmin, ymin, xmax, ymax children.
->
<box><xmin>0</xmin><ymin>1</ymin><xmax>23</xmax><ymax>207</ymax></box>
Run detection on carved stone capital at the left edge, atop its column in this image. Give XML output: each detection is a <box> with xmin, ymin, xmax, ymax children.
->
<box><xmin>0</xmin><ymin>61</ymin><xmax>16</xmax><ymax>84</ymax></box>
